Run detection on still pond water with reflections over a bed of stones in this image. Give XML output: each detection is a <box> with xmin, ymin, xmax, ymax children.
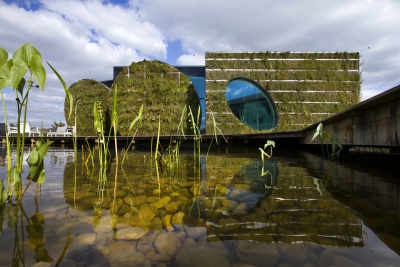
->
<box><xmin>0</xmin><ymin>147</ymin><xmax>400</xmax><ymax>266</ymax></box>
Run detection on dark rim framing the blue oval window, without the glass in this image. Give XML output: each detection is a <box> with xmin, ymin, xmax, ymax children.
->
<box><xmin>225</xmin><ymin>77</ymin><xmax>279</xmax><ymax>131</ymax></box>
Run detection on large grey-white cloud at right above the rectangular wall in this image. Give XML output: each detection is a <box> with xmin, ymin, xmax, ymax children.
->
<box><xmin>142</xmin><ymin>0</ymin><xmax>400</xmax><ymax>98</ymax></box>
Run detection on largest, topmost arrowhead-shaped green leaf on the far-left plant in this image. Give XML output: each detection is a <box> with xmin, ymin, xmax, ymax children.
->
<box><xmin>11</xmin><ymin>43</ymin><xmax>46</xmax><ymax>91</ymax></box>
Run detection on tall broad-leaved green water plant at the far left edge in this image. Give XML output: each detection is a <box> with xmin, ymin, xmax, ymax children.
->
<box><xmin>0</xmin><ymin>43</ymin><xmax>72</xmax><ymax>205</ymax></box>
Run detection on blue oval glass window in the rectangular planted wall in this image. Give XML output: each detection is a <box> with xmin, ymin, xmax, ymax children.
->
<box><xmin>225</xmin><ymin>77</ymin><xmax>278</xmax><ymax>130</ymax></box>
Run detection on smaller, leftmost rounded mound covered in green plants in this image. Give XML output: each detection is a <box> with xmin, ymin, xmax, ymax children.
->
<box><xmin>64</xmin><ymin>79</ymin><xmax>110</xmax><ymax>136</ymax></box>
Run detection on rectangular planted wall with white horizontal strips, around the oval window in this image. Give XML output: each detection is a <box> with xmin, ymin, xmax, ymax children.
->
<box><xmin>206</xmin><ymin>52</ymin><xmax>360</xmax><ymax>134</ymax></box>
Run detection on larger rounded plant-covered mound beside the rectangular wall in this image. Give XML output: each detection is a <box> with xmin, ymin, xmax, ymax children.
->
<box><xmin>109</xmin><ymin>60</ymin><xmax>199</xmax><ymax>136</ymax></box>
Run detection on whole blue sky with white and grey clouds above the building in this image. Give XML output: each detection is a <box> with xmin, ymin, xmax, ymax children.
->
<box><xmin>0</xmin><ymin>0</ymin><xmax>400</xmax><ymax>127</ymax></box>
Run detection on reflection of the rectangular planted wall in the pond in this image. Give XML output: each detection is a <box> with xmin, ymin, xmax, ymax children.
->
<box><xmin>206</xmin><ymin>156</ymin><xmax>363</xmax><ymax>246</ymax></box>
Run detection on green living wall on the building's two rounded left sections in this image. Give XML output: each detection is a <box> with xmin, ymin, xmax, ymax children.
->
<box><xmin>64</xmin><ymin>61</ymin><xmax>199</xmax><ymax>136</ymax></box>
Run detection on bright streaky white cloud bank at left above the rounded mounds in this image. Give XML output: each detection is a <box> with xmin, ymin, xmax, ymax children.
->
<box><xmin>0</xmin><ymin>0</ymin><xmax>167</xmax><ymax>127</ymax></box>
